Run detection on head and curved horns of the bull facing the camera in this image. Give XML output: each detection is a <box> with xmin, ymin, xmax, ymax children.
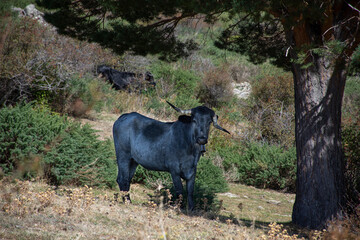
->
<box><xmin>166</xmin><ymin>101</ymin><xmax>230</xmax><ymax>145</ymax></box>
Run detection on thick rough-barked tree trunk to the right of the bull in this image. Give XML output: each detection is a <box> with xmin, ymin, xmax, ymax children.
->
<box><xmin>292</xmin><ymin>56</ymin><xmax>346</xmax><ymax>229</ymax></box>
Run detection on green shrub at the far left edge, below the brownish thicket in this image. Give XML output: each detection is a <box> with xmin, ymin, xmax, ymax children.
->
<box><xmin>0</xmin><ymin>104</ymin><xmax>69</xmax><ymax>173</ymax></box>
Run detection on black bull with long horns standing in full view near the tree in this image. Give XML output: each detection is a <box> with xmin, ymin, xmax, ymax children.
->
<box><xmin>113</xmin><ymin>102</ymin><xmax>229</xmax><ymax>210</ymax></box>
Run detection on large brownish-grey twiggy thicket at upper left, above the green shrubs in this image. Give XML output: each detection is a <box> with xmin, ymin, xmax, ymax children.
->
<box><xmin>0</xmin><ymin>12</ymin><xmax>115</xmax><ymax>107</ymax></box>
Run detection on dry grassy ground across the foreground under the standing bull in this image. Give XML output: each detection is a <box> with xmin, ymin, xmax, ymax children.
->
<box><xmin>0</xmin><ymin>179</ymin><xmax>304</xmax><ymax>240</ymax></box>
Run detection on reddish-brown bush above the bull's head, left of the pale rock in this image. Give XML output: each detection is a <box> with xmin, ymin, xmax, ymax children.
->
<box><xmin>197</xmin><ymin>66</ymin><xmax>233</xmax><ymax>107</ymax></box>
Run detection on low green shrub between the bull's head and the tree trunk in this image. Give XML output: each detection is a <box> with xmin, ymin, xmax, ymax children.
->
<box><xmin>217</xmin><ymin>142</ymin><xmax>296</xmax><ymax>191</ymax></box>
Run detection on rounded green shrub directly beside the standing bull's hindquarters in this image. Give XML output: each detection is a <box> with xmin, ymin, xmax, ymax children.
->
<box><xmin>44</xmin><ymin>123</ymin><xmax>117</xmax><ymax>187</ymax></box>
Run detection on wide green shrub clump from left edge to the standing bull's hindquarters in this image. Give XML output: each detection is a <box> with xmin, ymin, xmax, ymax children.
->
<box><xmin>0</xmin><ymin>104</ymin><xmax>116</xmax><ymax>187</ymax></box>
